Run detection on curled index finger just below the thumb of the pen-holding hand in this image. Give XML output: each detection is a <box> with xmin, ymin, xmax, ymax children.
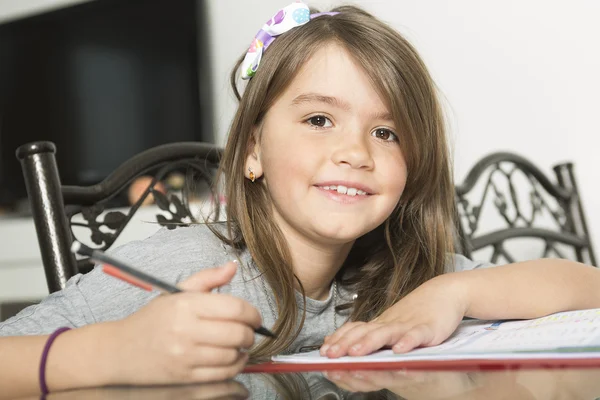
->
<box><xmin>172</xmin><ymin>292</ymin><xmax>262</xmax><ymax>328</ymax></box>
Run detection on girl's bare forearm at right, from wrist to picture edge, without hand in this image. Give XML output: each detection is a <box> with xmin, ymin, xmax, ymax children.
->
<box><xmin>451</xmin><ymin>259</ymin><xmax>600</xmax><ymax>319</ymax></box>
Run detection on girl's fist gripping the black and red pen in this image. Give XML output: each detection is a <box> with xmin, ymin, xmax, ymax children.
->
<box><xmin>103</xmin><ymin>262</ymin><xmax>261</xmax><ymax>385</ymax></box>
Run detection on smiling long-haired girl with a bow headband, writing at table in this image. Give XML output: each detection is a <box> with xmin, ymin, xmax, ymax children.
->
<box><xmin>0</xmin><ymin>3</ymin><xmax>600</xmax><ymax>395</ymax></box>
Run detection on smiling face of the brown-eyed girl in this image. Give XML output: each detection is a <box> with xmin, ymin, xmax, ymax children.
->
<box><xmin>246</xmin><ymin>44</ymin><xmax>407</xmax><ymax>244</ymax></box>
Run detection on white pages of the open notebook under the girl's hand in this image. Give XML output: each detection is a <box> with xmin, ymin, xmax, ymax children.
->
<box><xmin>273</xmin><ymin>309</ymin><xmax>600</xmax><ymax>364</ymax></box>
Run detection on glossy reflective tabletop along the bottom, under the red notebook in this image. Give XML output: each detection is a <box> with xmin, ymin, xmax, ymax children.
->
<box><xmin>19</xmin><ymin>367</ymin><xmax>600</xmax><ymax>400</ymax></box>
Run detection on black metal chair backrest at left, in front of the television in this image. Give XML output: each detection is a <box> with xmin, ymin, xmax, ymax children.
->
<box><xmin>17</xmin><ymin>142</ymin><xmax>222</xmax><ymax>293</ymax></box>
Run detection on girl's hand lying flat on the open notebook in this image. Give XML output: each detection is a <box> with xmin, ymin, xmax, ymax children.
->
<box><xmin>320</xmin><ymin>274</ymin><xmax>468</xmax><ymax>358</ymax></box>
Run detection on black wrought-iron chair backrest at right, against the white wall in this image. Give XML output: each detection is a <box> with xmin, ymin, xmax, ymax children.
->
<box><xmin>456</xmin><ymin>152</ymin><xmax>596</xmax><ymax>266</ymax></box>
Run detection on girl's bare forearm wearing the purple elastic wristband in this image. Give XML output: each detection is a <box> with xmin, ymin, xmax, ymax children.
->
<box><xmin>0</xmin><ymin>324</ymin><xmax>119</xmax><ymax>399</ymax></box>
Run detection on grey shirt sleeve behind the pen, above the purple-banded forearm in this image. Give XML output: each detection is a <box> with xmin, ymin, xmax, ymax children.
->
<box><xmin>0</xmin><ymin>226</ymin><xmax>230</xmax><ymax>336</ymax></box>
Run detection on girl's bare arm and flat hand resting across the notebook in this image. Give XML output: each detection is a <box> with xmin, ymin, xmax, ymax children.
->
<box><xmin>321</xmin><ymin>259</ymin><xmax>600</xmax><ymax>358</ymax></box>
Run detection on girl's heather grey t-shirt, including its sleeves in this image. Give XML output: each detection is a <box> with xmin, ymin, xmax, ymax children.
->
<box><xmin>0</xmin><ymin>225</ymin><xmax>489</xmax><ymax>352</ymax></box>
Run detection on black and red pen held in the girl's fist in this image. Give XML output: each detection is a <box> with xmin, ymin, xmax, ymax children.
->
<box><xmin>71</xmin><ymin>241</ymin><xmax>277</xmax><ymax>338</ymax></box>
